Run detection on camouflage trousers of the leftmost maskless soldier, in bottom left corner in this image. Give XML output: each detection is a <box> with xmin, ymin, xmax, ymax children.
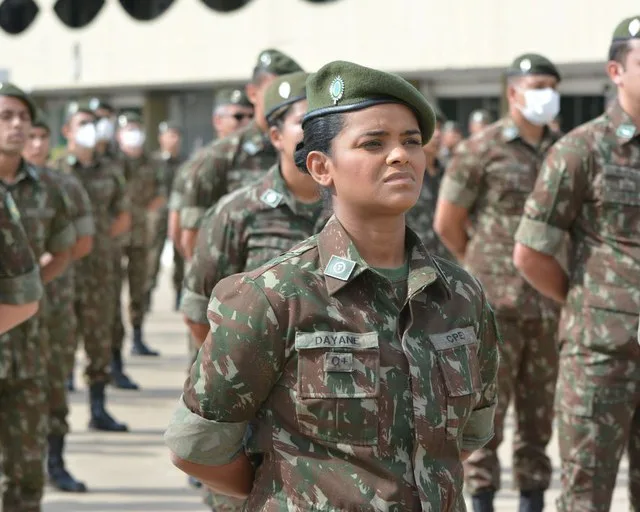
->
<box><xmin>0</xmin><ymin>378</ymin><xmax>48</xmax><ymax>512</ymax></box>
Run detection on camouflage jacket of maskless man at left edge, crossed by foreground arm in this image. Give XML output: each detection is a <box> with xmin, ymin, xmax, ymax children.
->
<box><xmin>0</xmin><ymin>161</ymin><xmax>76</xmax><ymax>379</ymax></box>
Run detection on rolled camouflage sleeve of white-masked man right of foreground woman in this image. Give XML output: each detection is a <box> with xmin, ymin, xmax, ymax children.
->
<box><xmin>438</xmin><ymin>140</ymin><xmax>483</xmax><ymax>210</ymax></box>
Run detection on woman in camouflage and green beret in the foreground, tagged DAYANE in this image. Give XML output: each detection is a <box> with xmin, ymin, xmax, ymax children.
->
<box><xmin>166</xmin><ymin>61</ymin><xmax>498</xmax><ymax>512</ymax></box>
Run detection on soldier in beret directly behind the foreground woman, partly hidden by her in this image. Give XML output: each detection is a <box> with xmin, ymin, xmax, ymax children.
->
<box><xmin>181</xmin><ymin>72</ymin><xmax>329</xmax><ymax>511</ymax></box>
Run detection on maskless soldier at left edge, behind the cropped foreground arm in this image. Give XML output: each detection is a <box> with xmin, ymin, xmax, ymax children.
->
<box><xmin>0</xmin><ymin>82</ymin><xmax>75</xmax><ymax>512</ymax></box>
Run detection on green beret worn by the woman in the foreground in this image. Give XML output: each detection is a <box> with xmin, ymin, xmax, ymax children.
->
<box><xmin>302</xmin><ymin>61</ymin><xmax>436</xmax><ymax>144</ymax></box>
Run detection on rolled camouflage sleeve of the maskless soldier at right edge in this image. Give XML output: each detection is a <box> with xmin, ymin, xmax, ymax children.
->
<box><xmin>515</xmin><ymin>135</ymin><xmax>591</xmax><ymax>256</ymax></box>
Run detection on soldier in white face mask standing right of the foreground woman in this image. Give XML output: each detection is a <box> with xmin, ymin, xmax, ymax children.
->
<box><xmin>435</xmin><ymin>54</ymin><xmax>560</xmax><ymax>512</ymax></box>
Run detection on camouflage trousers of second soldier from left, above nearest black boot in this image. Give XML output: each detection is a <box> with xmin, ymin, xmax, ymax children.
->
<box><xmin>47</xmin><ymin>297</ymin><xmax>77</xmax><ymax>436</ymax></box>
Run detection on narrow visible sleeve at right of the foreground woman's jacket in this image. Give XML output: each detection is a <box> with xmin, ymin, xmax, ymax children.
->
<box><xmin>462</xmin><ymin>280</ymin><xmax>501</xmax><ymax>451</ymax></box>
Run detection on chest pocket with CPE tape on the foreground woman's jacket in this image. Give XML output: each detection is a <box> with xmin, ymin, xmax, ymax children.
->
<box><xmin>429</xmin><ymin>327</ymin><xmax>482</xmax><ymax>439</ymax></box>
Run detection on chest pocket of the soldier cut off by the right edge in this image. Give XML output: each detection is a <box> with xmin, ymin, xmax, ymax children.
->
<box><xmin>600</xmin><ymin>165</ymin><xmax>640</xmax><ymax>237</ymax></box>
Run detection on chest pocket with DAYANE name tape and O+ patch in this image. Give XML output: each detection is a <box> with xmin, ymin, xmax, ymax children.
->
<box><xmin>295</xmin><ymin>332</ymin><xmax>380</xmax><ymax>446</ymax></box>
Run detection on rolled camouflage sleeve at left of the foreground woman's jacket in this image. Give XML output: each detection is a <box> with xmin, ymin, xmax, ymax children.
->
<box><xmin>165</xmin><ymin>274</ymin><xmax>286</xmax><ymax>466</ymax></box>
